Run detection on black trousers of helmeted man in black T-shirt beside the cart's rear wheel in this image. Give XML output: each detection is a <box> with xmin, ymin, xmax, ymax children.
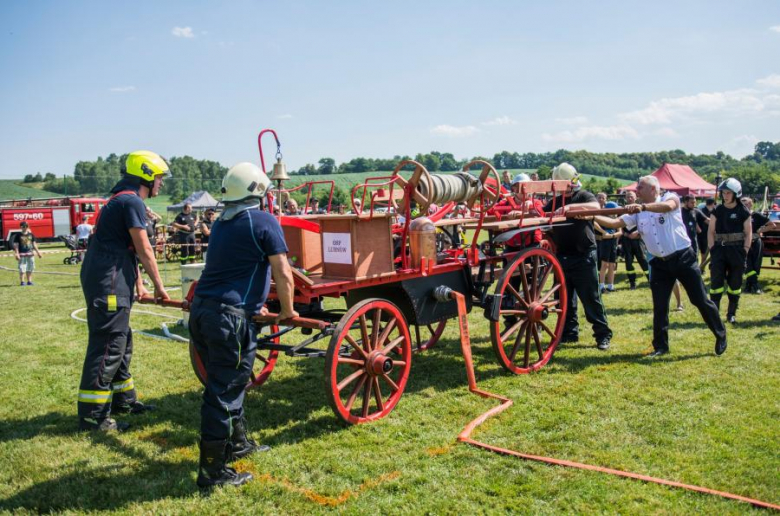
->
<box><xmin>558</xmin><ymin>248</ymin><xmax>612</xmax><ymax>342</ymax></box>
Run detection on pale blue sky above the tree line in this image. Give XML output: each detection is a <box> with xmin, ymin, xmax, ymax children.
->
<box><xmin>0</xmin><ymin>0</ymin><xmax>780</xmax><ymax>178</ymax></box>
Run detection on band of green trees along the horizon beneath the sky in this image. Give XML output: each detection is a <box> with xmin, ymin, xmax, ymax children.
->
<box><xmin>32</xmin><ymin>141</ymin><xmax>780</xmax><ymax>202</ymax></box>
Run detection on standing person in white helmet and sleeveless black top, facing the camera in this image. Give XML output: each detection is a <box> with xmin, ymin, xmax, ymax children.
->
<box><xmin>707</xmin><ymin>177</ymin><xmax>753</xmax><ymax>324</ymax></box>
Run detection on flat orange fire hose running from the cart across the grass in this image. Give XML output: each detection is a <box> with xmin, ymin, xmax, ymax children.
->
<box><xmin>442</xmin><ymin>287</ymin><xmax>780</xmax><ymax>511</ymax></box>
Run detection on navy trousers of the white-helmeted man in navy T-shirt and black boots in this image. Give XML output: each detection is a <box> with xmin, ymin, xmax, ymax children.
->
<box><xmin>189</xmin><ymin>297</ymin><xmax>257</xmax><ymax>441</ymax></box>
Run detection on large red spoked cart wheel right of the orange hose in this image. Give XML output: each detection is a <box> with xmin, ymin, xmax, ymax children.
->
<box><xmin>490</xmin><ymin>248</ymin><xmax>566</xmax><ymax>374</ymax></box>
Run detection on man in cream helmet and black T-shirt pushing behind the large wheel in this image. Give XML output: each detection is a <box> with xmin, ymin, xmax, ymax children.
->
<box><xmin>544</xmin><ymin>163</ymin><xmax>612</xmax><ymax>350</ymax></box>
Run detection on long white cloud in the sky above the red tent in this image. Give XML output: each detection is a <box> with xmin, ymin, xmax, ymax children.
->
<box><xmin>619</xmin><ymin>88</ymin><xmax>766</xmax><ymax>125</ymax></box>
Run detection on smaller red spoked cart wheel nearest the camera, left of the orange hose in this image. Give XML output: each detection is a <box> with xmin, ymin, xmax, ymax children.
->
<box><xmin>325</xmin><ymin>299</ymin><xmax>412</xmax><ymax>424</ymax></box>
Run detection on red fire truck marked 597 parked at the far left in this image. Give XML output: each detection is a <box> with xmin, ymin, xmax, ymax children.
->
<box><xmin>0</xmin><ymin>197</ymin><xmax>108</xmax><ymax>249</ymax></box>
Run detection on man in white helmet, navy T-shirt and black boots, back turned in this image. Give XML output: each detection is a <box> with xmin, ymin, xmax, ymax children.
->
<box><xmin>189</xmin><ymin>163</ymin><xmax>298</xmax><ymax>489</ymax></box>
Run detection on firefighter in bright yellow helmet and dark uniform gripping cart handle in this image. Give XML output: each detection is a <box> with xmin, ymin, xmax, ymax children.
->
<box><xmin>78</xmin><ymin>151</ymin><xmax>170</xmax><ymax>430</ymax></box>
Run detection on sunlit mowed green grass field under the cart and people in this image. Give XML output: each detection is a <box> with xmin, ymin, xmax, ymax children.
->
<box><xmin>0</xmin><ymin>248</ymin><xmax>780</xmax><ymax>514</ymax></box>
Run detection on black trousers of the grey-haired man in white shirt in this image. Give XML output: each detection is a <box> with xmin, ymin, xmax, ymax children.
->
<box><xmin>650</xmin><ymin>247</ymin><xmax>726</xmax><ymax>351</ymax></box>
